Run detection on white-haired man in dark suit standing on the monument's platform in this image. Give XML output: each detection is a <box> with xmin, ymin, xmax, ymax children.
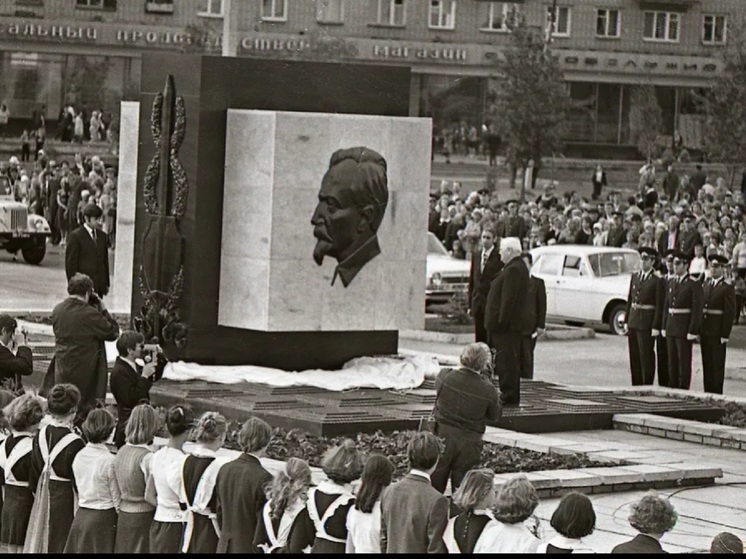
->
<box><xmin>484</xmin><ymin>237</ymin><xmax>529</xmax><ymax>406</ymax></box>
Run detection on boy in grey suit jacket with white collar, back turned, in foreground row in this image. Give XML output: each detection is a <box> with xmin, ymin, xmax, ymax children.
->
<box><xmin>381</xmin><ymin>432</ymin><xmax>449</xmax><ymax>553</ymax></box>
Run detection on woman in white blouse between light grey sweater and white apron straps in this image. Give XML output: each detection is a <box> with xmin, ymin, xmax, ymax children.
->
<box><xmin>145</xmin><ymin>406</ymin><xmax>194</xmax><ymax>553</ymax></box>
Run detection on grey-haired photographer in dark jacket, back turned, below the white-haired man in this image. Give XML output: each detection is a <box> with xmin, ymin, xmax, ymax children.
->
<box><xmin>431</xmin><ymin>342</ymin><xmax>502</xmax><ymax>493</ymax></box>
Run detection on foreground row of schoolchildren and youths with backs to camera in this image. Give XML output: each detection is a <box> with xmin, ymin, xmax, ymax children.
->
<box><xmin>0</xmin><ymin>384</ymin><xmax>732</xmax><ymax>553</ymax></box>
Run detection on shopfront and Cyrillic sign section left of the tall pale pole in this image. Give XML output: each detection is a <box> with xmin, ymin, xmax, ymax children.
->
<box><xmin>0</xmin><ymin>18</ymin><xmax>220</xmax><ymax>135</ymax></box>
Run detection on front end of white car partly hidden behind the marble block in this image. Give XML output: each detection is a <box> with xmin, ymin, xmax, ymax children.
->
<box><xmin>425</xmin><ymin>232</ymin><xmax>471</xmax><ymax>304</ymax></box>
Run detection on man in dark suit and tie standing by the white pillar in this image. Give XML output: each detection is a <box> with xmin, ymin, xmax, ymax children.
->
<box><xmin>65</xmin><ymin>204</ymin><xmax>109</xmax><ymax>297</ymax></box>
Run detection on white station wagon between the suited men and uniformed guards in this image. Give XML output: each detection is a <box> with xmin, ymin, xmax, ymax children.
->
<box><xmin>531</xmin><ymin>245</ymin><xmax>642</xmax><ymax>335</ymax></box>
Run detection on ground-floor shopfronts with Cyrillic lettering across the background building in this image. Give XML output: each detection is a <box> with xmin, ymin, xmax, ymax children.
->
<box><xmin>0</xmin><ymin>18</ymin><xmax>722</xmax><ymax>155</ymax></box>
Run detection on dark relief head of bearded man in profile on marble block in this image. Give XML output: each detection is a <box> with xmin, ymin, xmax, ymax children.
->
<box><xmin>311</xmin><ymin>147</ymin><xmax>389</xmax><ymax>287</ymax></box>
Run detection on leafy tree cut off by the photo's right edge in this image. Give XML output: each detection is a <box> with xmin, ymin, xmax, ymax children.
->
<box><xmin>698</xmin><ymin>18</ymin><xmax>746</xmax><ymax>182</ymax></box>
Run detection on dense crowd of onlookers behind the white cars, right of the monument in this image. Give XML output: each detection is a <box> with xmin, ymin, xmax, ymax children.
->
<box><xmin>428</xmin><ymin>164</ymin><xmax>746</xmax><ymax>278</ymax></box>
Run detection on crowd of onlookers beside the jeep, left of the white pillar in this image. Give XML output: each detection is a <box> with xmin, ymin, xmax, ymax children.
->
<box><xmin>0</xmin><ymin>153</ymin><xmax>117</xmax><ymax>248</ymax></box>
